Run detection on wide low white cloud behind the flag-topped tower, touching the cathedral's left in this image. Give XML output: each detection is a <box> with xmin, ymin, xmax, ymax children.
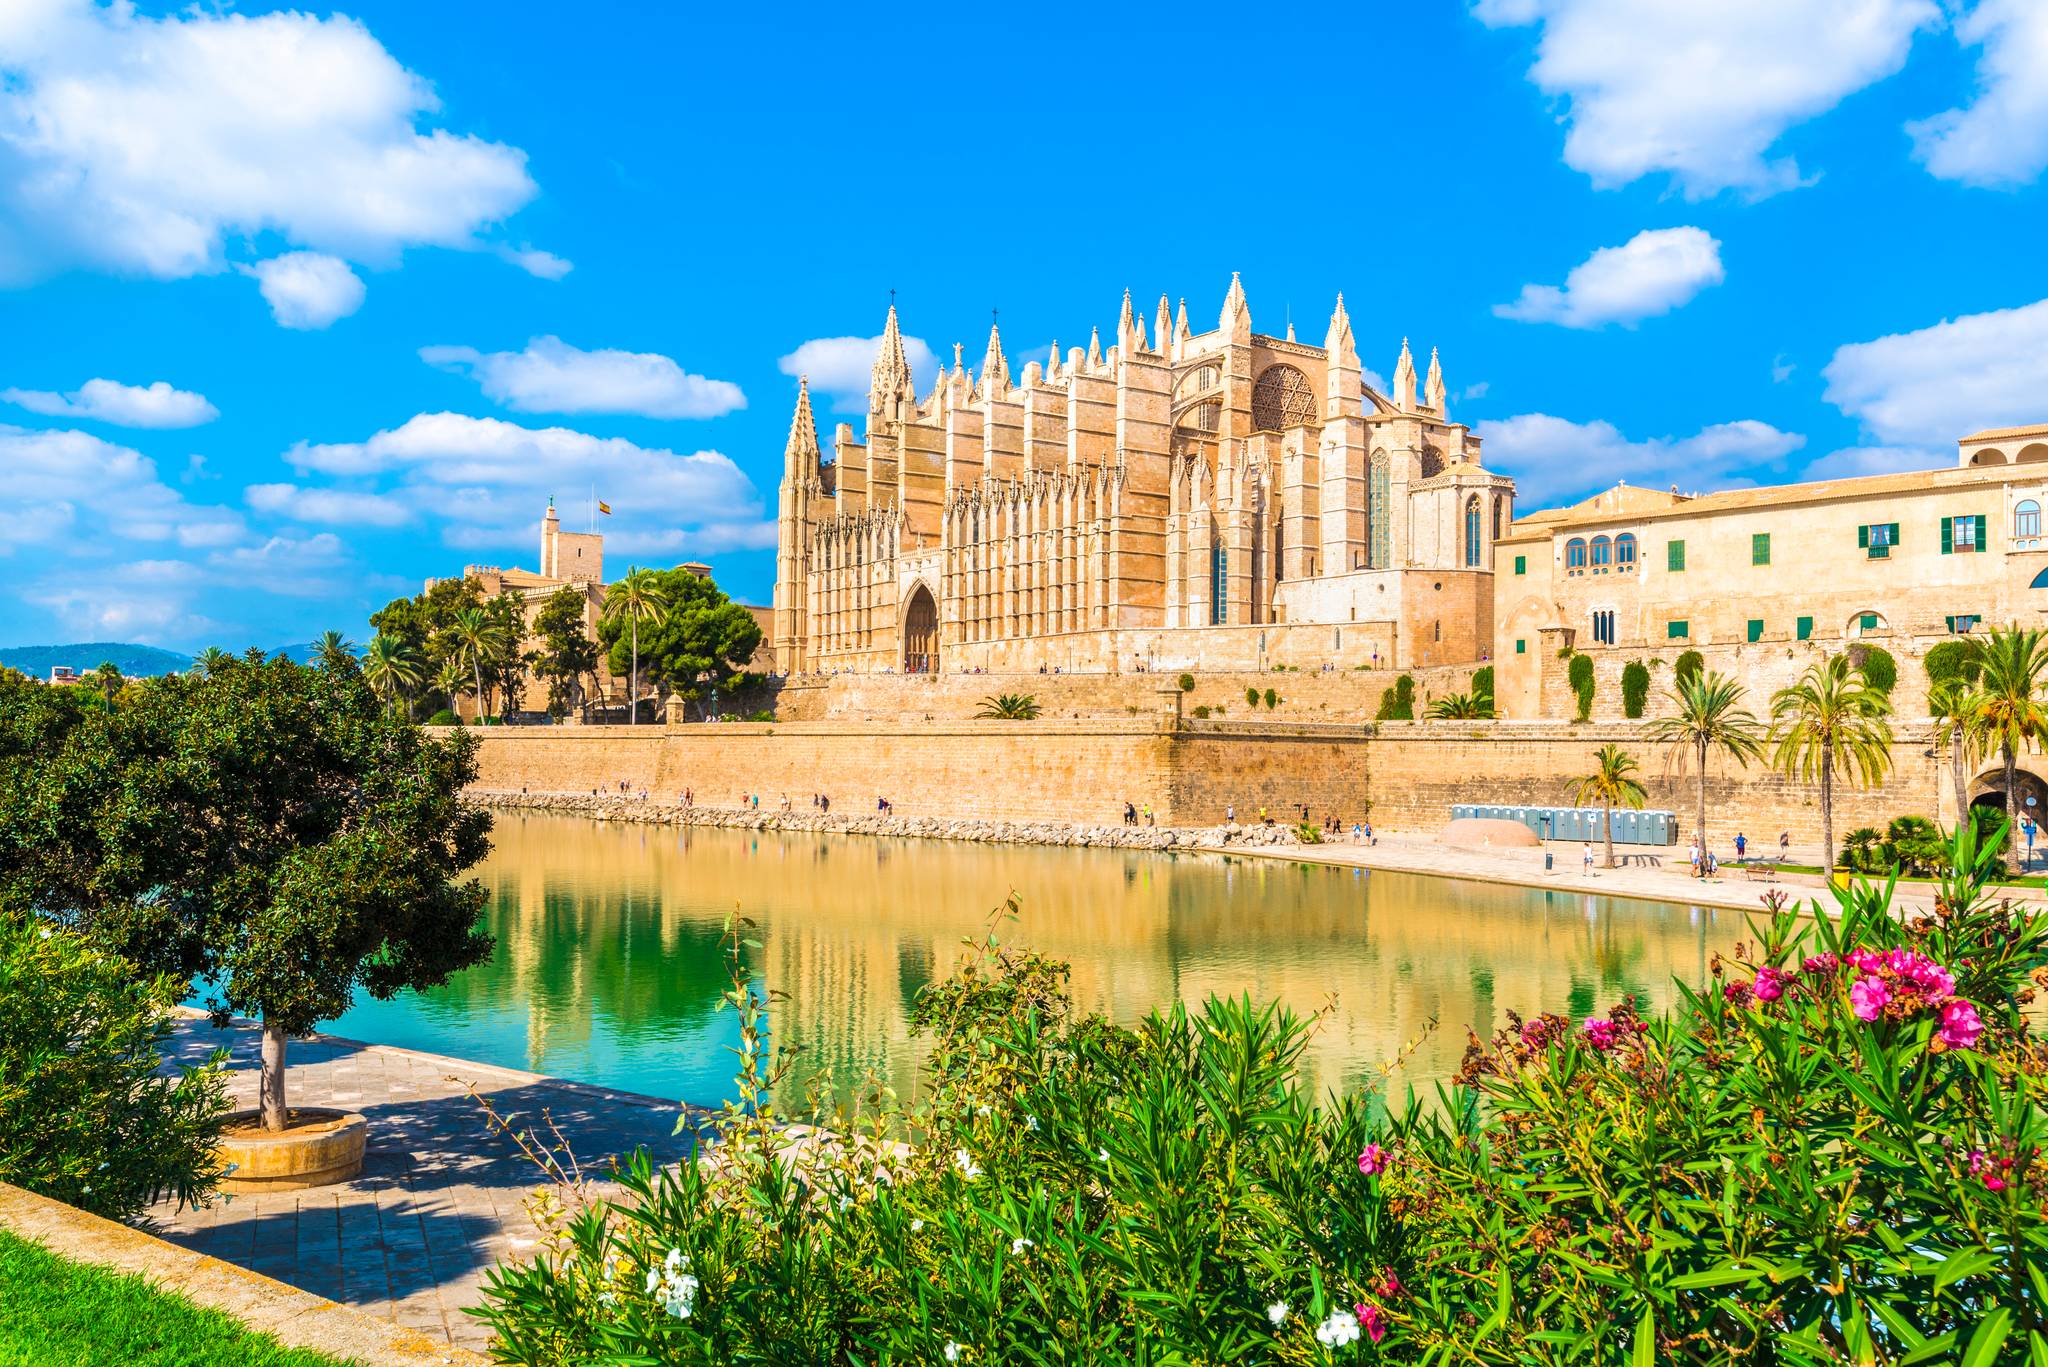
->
<box><xmin>285</xmin><ymin>412</ymin><xmax>774</xmax><ymax>551</ymax></box>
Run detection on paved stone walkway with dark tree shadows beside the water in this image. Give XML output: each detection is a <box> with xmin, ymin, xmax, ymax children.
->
<box><xmin>150</xmin><ymin>1019</ymin><xmax>684</xmax><ymax>1349</ymax></box>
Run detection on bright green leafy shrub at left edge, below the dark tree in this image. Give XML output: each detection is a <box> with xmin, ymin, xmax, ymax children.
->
<box><xmin>0</xmin><ymin>910</ymin><xmax>229</xmax><ymax>1219</ymax></box>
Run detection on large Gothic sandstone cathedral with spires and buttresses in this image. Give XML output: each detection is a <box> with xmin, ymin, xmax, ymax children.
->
<box><xmin>772</xmin><ymin>277</ymin><xmax>1513</xmax><ymax>674</ymax></box>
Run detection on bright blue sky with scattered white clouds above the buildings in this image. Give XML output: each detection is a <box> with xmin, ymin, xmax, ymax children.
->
<box><xmin>0</xmin><ymin>0</ymin><xmax>2048</xmax><ymax>650</ymax></box>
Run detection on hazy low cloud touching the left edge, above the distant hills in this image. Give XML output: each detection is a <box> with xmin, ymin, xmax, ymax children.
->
<box><xmin>0</xmin><ymin>426</ymin><xmax>244</xmax><ymax>557</ymax></box>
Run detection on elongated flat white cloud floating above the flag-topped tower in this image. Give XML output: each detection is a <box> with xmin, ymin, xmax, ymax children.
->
<box><xmin>420</xmin><ymin>336</ymin><xmax>748</xmax><ymax>418</ymax></box>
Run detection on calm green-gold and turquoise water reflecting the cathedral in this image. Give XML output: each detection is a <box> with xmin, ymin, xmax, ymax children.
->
<box><xmin>326</xmin><ymin>814</ymin><xmax>1745</xmax><ymax>1103</ymax></box>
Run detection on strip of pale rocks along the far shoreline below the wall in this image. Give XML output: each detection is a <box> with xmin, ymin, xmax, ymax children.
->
<box><xmin>469</xmin><ymin>789</ymin><xmax>1303</xmax><ymax>851</ymax></box>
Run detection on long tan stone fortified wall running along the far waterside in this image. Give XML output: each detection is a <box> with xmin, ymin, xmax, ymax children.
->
<box><xmin>464</xmin><ymin>711</ymin><xmax>1954</xmax><ymax>844</ymax></box>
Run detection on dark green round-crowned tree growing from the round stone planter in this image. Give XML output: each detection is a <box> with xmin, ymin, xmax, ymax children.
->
<box><xmin>14</xmin><ymin>652</ymin><xmax>492</xmax><ymax>1180</ymax></box>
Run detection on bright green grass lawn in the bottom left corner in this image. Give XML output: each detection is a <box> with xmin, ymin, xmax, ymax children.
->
<box><xmin>0</xmin><ymin>1230</ymin><xmax>360</xmax><ymax>1367</ymax></box>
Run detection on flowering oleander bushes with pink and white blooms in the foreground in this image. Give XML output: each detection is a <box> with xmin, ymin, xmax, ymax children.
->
<box><xmin>481</xmin><ymin>830</ymin><xmax>2048</xmax><ymax>1367</ymax></box>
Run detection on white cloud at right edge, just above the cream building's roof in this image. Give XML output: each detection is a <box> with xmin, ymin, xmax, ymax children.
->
<box><xmin>1823</xmin><ymin>299</ymin><xmax>2048</xmax><ymax>449</ymax></box>
